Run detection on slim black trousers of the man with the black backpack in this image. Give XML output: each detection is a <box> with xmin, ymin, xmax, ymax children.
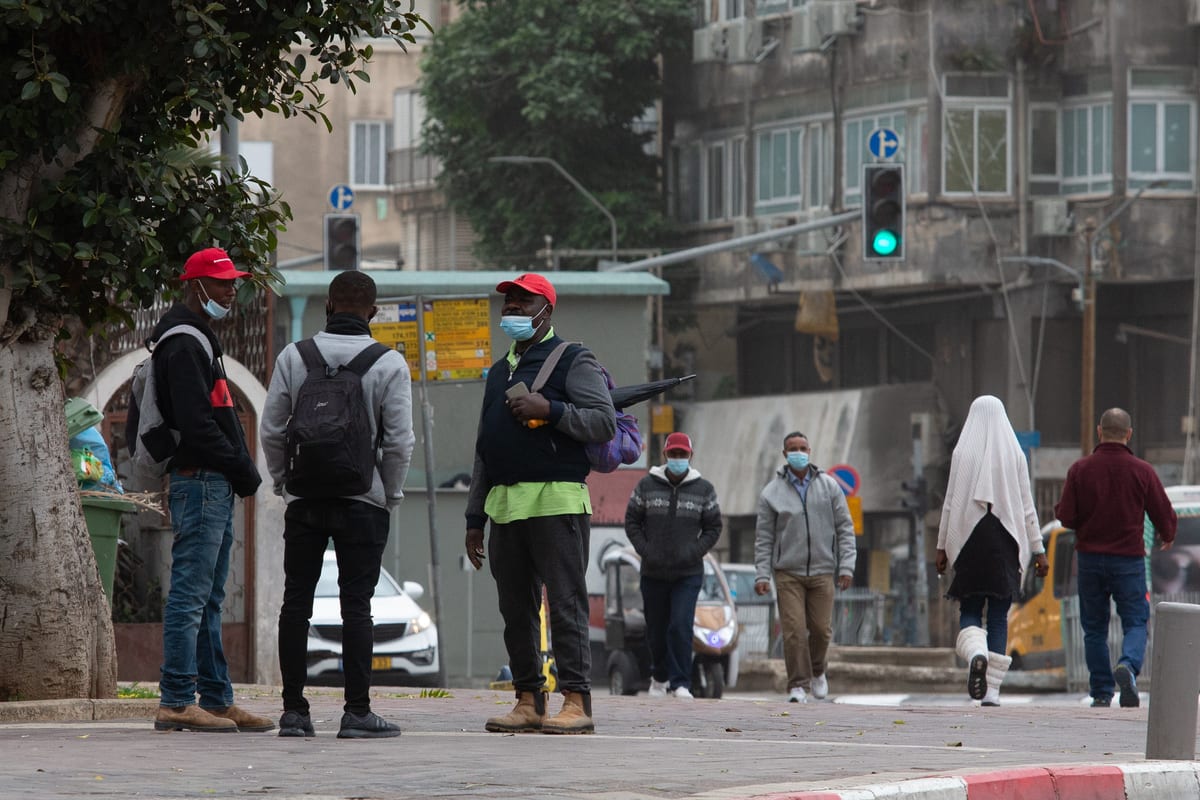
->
<box><xmin>280</xmin><ymin>499</ymin><xmax>390</xmax><ymax>716</ymax></box>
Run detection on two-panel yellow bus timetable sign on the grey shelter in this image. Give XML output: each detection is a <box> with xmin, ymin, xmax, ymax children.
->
<box><xmin>371</xmin><ymin>297</ymin><xmax>492</xmax><ymax>380</ymax></box>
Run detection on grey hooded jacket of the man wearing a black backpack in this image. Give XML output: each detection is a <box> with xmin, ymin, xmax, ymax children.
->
<box><xmin>259</xmin><ymin>331</ymin><xmax>416</xmax><ymax>509</ymax></box>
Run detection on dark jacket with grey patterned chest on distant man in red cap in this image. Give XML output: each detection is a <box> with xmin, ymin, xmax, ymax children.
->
<box><xmin>625</xmin><ymin>467</ymin><xmax>721</xmax><ymax>581</ymax></box>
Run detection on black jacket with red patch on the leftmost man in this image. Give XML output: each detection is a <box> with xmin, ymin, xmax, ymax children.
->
<box><xmin>150</xmin><ymin>303</ymin><xmax>263</xmax><ymax>498</ymax></box>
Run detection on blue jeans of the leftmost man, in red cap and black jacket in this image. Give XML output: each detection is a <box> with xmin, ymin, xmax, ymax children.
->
<box><xmin>158</xmin><ymin>469</ymin><xmax>233</xmax><ymax>709</ymax></box>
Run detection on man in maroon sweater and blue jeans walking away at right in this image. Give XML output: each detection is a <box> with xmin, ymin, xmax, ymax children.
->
<box><xmin>1055</xmin><ymin>408</ymin><xmax>1176</xmax><ymax>708</ymax></box>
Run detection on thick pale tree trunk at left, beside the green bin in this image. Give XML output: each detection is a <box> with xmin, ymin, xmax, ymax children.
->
<box><xmin>0</xmin><ymin>339</ymin><xmax>116</xmax><ymax>700</ymax></box>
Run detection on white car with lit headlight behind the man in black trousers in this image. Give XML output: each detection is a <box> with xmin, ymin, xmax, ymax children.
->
<box><xmin>308</xmin><ymin>551</ymin><xmax>438</xmax><ymax>686</ymax></box>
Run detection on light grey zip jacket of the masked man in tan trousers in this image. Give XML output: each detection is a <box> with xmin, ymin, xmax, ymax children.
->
<box><xmin>754</xmin><ymin>465</ymin><xmax>857</xmax><ymax>581</ymax></box>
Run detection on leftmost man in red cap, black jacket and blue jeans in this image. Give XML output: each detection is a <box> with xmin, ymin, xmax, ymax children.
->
<box><xmin>150</xmin><ymin>247</ymin><xmax>268</xmax><ymax>732</ymax></box>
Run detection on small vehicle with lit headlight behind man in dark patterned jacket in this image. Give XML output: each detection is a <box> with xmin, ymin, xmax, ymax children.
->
<box><xmin>600</xmin><ymin>546</ymin><xmax>738</xmax><ymax>699</ymax></box>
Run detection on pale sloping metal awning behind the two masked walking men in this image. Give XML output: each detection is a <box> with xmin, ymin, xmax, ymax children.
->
<box><xmin>682</xmin><ymin>384</ymin><xmax>948</xmax><ymax>516</ymax></box>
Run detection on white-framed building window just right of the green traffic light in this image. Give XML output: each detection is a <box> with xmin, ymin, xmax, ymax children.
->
<box><xmin>942</xmin><ymin>74</ymin><xmax>1012</xmax><ymax>194</ymax></box>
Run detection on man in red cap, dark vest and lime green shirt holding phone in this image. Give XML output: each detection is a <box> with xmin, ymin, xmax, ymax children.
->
<box><xmin>466</xmin><ymin>272</ymin><xmax>617</xmax><ymax>733</ymax></box>
